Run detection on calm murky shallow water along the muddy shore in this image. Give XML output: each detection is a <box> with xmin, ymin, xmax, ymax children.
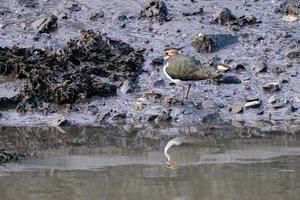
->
<box><xmin>0</xmin><ymin>127</ymin><xmax>300</xmax><ymax>200</ymax></box>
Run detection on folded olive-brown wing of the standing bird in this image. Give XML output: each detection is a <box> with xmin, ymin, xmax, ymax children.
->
<box><xmin>166</xmin><ymin>55</ymin><xmax>218</xmax><ymax>81</ymax></box>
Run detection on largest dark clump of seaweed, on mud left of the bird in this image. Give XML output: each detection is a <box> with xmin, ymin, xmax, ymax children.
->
<box><xmin>0</xmin><ymin>31</ymin><xmax>143</xmax><ymax>112</ymax></box>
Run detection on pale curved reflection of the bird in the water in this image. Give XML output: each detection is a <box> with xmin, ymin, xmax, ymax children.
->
<box><xmin>164</xmin><ymin>136</ymin><xmax>196</xmax><ymax>169</ymax></box>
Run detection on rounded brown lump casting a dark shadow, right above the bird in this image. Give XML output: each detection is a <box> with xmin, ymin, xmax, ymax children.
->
<box><xmin>192</xmin><ymin>33</ymin><xmax>216</xmax><ymax>53</ymax></box>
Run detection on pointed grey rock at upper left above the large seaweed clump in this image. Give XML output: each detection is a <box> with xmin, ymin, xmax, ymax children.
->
<box><xmin>31</xmin><ymin>15</ymin><xmax>57</xmax><ymax>33</ymax></box>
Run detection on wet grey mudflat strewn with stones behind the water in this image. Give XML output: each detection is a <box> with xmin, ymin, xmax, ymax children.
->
<box><xmin>0</xmin><ymin>0</ymin><xmax>300</xmax><ymax>129</ymax></box>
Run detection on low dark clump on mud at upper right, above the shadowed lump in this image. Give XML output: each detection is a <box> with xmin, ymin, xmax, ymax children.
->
<box><xmin>213</xmin><ymin>8</ymin><xmax>261</xmax><ymax>31</ymax></box>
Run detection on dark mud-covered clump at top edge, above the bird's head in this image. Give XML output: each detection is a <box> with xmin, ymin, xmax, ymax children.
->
<box><xmin>139</xmin><ymin>0</ymin><xmax>171</xmax><ymax>22</ymax></box>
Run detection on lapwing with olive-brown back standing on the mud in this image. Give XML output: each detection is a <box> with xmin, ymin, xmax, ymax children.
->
<box><xmin>163</xmin><ymin>49</ymin><xmax>219</xmax><ymax>100</ymax></box>
